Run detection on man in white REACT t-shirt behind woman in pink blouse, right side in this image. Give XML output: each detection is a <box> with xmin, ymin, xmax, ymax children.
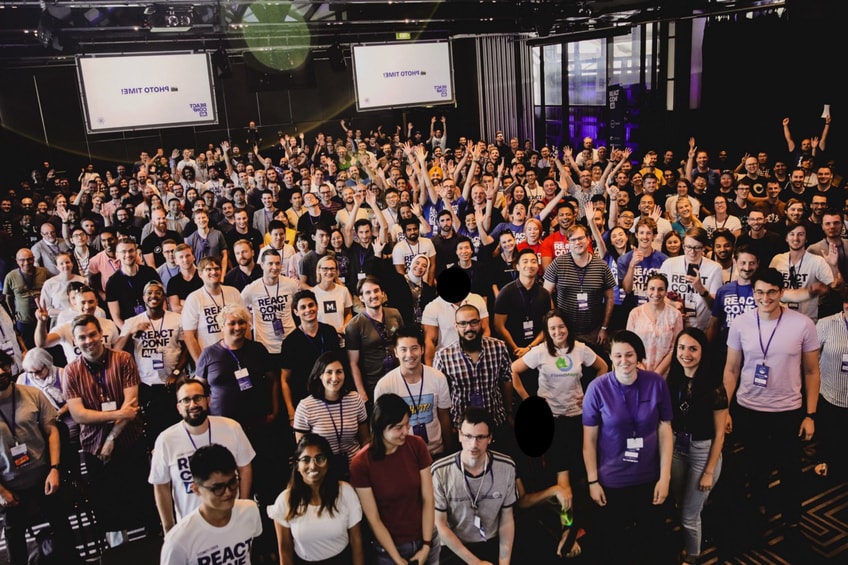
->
<box><xmin>660</xmin><ymin>227</ymin><xmax>722</xmax><ymax>331</ymax></box>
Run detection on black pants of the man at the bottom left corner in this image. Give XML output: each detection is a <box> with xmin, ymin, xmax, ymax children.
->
<box><xmin>3</xmin><ymin>476</ymin><xmax>75</xmax><ymax>565</ymax></box>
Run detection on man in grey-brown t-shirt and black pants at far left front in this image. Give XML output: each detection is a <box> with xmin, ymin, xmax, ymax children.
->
<box><xmin>0</xmin><ymin>351</ymin><xmax>82</xmax><ymax>565</ymax></box>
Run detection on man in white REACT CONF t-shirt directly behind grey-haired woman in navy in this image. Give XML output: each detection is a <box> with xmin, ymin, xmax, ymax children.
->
<box><xmin>182</xmin><ymin>257</ymin><xmax>244</xmax><ymax>363</ymax></box>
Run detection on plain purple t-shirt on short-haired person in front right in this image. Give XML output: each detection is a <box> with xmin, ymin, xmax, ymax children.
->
<box><xmin>583</xmin><ymin>370</ymin><xmax>673</xmax><ymax>488</ymax></box>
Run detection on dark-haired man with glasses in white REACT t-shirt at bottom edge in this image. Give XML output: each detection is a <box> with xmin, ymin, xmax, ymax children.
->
<box><xmin>159</xmin><ymin>444</ymin><xmax>262</xmax><ymax>565</ymax></box>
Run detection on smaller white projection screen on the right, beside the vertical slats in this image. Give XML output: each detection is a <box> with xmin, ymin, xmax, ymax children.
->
<box><xmin>351</xmin><ymin>41</ymin><xmax>455</xmax><ymax>111</ymax></box>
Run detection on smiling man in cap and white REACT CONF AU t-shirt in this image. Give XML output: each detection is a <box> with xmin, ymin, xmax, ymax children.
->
<box><xmin>121</xmin><ymin>281</ymin><xmax>188</xmax><ymax>448</ymax></box>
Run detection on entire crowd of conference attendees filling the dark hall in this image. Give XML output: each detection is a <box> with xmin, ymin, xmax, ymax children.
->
<box><xmin>0</xmin><ymin>111</ymin><xmax>848</xmax><ymax>565</ymax></box>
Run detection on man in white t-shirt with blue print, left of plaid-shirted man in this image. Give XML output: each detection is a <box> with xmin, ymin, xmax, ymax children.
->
<box><xmin>374</xmin><ymin>326</ymin><xmax>453</xmax><ymax>458</ymax></box>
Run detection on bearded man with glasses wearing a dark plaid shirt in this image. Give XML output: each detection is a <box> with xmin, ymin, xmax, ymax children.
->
<box><xmin>433</xmin><ymin>304</ymin><xmax>514</xmax><ymax>451</ymax></box>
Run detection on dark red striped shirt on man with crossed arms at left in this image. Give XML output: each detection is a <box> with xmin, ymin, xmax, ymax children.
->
<box><xmin>64</xmin><ymin>349</ymin><xmax>142</xmax><ymax>455</ymax></box>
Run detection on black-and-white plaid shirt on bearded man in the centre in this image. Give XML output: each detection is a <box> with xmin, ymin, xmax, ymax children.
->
<box><xmin>433</xmin><ymin>337</ymin><xmax>512</xmax><ymax>428</ymax></box>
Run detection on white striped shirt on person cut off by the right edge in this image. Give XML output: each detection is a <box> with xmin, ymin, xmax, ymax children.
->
<box><xmin>816</xmin><ymin>312</ymin><xmax>848</xmax><ymax>408</ymax></box>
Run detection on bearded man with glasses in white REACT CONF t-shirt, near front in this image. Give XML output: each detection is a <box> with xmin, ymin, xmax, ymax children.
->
<box><xmin>148</xmin><ymin>379</ymin><xmax>256</xmax><ymax>533</ymax></box>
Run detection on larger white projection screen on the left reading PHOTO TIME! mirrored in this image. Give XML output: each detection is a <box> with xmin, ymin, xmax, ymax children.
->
<box><xmin>77</xmin><ymin>53</ymin><xmax>218</xmax><ymax>133</ymax></box>
